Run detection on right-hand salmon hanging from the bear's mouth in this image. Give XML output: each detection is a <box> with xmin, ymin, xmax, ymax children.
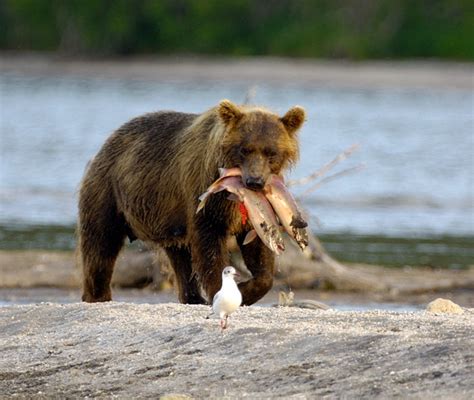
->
<box><xmin>264</xmin><ymin>175</ymin><xmax>308</xmax><ymax>250</ymax></box>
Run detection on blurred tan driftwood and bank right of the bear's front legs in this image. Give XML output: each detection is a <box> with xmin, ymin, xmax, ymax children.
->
<box><xmin>275</xmin><ymin>236</ymin><xmax>474</xmax><ymax>299</ymax></box>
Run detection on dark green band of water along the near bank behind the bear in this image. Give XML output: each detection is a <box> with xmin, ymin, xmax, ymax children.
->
<box><xmin>0</xmin><ymin>224</ymin><xmax>474</xmax><ymax>269</ymax></box>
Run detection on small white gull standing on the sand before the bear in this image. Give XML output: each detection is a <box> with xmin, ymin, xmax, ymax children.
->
<box><xmin>212</xmin><ymin>267</ymin><xmax>242</xmax><ymax>330</ymax></box>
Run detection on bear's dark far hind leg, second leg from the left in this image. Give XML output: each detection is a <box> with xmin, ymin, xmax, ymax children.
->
<box><xmin>165</xmin><ymin>247</ymin><xmax>206</xmax><ymax>304</ymax></box>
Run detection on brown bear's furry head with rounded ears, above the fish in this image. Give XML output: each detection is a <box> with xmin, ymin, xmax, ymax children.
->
<box><xmin>217</xmin><ymin>100</ymin><xmax>305</xmax><ymax>190</ymax></box>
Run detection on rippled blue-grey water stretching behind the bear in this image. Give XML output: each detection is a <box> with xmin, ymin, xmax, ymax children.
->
<box><xmin>0</xmin><ymin>67</ymin><xmax>474</xmax><ymax>265</ymax></box>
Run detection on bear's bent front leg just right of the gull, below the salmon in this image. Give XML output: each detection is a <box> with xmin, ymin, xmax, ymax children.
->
<box><xmin>237</xmin><ymin>232</ymin><xmax>275</xmax><ymax>306</ymax></box>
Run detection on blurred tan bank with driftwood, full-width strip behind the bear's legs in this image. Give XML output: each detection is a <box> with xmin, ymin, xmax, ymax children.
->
<box><xmin>0</xmin><ymin>248</ymin><xmax>474</xmax><ymax>299</ymax></box>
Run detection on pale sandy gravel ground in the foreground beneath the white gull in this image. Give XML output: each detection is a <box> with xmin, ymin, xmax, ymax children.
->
<box><xmin>0</xmin><ymin>303</ymin><xmax>474</xmax><ymax>399</ymax></box>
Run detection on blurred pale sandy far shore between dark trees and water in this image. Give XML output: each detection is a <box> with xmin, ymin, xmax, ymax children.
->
<box><xmin>0</xmin><ymin>52</ymin><xmax>474</xmax><ymax>90</ymax></box>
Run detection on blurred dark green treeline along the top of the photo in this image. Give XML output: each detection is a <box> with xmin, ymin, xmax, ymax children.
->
<box><xmin>0</xmin><ymin>0</ymin><xmax>474</xmax><ymax>60</ymax></box>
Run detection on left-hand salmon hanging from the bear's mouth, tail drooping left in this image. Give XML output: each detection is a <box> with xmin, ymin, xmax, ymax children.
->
<box><xmin>196</xmin><ymin>175</ymin><xmax>285</xmax><ymax>255</ymax></box>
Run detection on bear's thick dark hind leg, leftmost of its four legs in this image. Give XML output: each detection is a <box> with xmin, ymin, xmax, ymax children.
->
<box><xmin>79</xmin><ymin>208</ymin><xmax>125</xmax><ymax>303</ymax></box>
